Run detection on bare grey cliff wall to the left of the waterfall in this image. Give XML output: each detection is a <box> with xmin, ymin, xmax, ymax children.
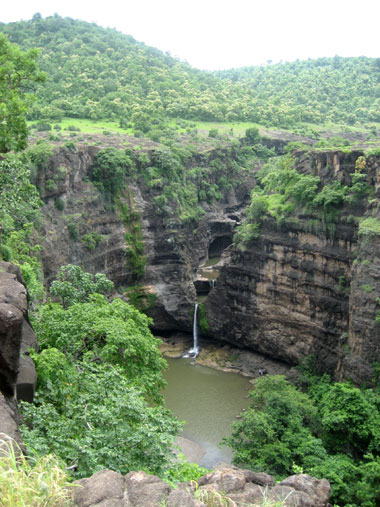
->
<box><xmin>37</xmin><ymin>146</ymin><xmax>253</xmax><ymax>331</ymax></box>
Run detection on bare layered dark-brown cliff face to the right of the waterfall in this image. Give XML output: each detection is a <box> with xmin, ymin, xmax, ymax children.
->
<box><xmin>205</xmin><ymin>152</ymin><xmax>380</xmax><ymax>383</ymax></box>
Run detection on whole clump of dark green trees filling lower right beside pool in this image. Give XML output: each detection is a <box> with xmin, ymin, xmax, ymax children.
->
<box><xmin>224</xmin><ymin>372</ymin><xmax>380</xmax><ymax>507</ymax></box>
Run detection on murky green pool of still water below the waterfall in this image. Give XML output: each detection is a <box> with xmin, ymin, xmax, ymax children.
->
<box><xmin>164</xmin><ymin>358</ymin><xmax>252</xmax><ymax>468</ymax></box>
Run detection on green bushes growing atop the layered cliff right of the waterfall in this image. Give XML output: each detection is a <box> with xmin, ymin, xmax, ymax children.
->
<box><xmin>235</xmin><ymin>154</ymin><xmax>377</xmax><ymax>245</ymax></box>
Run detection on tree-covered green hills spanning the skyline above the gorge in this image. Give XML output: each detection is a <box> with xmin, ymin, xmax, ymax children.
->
<box><xmin>0</xmin><ymin>15</ymin><xmax>380</xmax><ymax>131</ymax></box>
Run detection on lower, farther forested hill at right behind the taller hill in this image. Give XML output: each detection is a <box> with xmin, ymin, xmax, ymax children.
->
<box><xmin>218</xmin><ymin>56</ymin><xmax>380</xmax><ymax>125</ymax></box>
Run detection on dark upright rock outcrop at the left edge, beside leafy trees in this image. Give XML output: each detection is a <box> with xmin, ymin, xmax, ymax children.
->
<box><xmin>0</xmin><ymin>262</ymin><xmax>37</xmax><ymax>452</ymax></box>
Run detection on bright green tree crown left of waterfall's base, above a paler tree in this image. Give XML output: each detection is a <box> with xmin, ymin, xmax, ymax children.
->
<box><xmin>33</xmin><ymin>294</ymin><xmax>166</xmax><ymax>400</ymax></box>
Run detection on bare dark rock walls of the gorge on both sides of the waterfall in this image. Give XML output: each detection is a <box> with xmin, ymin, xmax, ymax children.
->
<box><xmin>39</xmin><ymin>142</ymin><xmax>380</xmax><ymax>383</ymax></box>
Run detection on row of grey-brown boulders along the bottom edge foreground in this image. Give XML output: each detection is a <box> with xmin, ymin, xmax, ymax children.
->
<box><xmin>74</xmin><ymin>466</ymin><xmax>330</xmax><ymax>507</ymax></box>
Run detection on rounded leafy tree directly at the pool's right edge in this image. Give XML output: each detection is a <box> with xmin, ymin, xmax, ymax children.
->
<box><xmin>224</xmin><ymin>376</ymin><xmax>326</xmax><ymax>477</ymax></box>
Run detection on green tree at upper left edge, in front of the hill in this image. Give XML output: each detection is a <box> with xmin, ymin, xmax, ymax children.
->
<box><xmin>0</xmin><ymin>33</ymin><xmax>44</xmax><ymax>153</ymax></box>
